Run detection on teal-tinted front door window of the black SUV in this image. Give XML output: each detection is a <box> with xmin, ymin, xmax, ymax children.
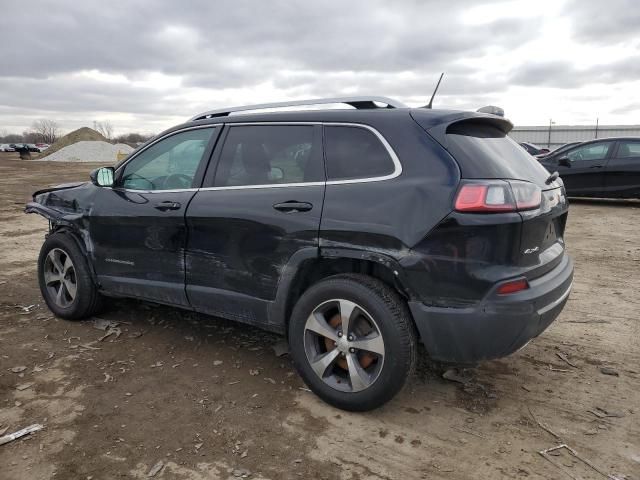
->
<box><xmin>120</xmin><ymin>128</ymin><xmax>214</xmax><ymax>190</ymax></box>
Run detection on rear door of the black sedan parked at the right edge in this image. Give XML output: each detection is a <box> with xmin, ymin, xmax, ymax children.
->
<box><xmin>605</xmin><ymin>138</ymin><xmax>640</xmax><ymax>198</ymax></box>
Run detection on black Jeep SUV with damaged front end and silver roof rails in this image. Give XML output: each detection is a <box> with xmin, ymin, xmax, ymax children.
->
<box><xmin>26</xmin><ymin>97</ymin><xmax>573</xmax><ymax>410</ymax></box>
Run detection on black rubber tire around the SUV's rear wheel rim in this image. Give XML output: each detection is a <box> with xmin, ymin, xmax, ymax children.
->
<box><xmin>289</xmin><ymin>274</ymin><xmax>417</xmax><ymax>411</ymax></box>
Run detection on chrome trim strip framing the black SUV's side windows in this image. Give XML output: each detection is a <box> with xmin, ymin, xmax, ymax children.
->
<box><xmin>116</xmin><ymin>121</ymin><xmax>402</xmax><ymax>193</ymax></box>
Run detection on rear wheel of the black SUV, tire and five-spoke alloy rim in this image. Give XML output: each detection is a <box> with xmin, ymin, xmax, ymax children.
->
<box><xmin>289</xmin><ymin>274</ymin><xmax>416</xmax><ymax>411</ymax></box>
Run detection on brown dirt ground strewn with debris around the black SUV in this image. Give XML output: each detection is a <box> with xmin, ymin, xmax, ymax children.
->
<box><xmin>0</xmin><ymin>154</ymin><xmax>640</xmax><ymax>480</ymax></box>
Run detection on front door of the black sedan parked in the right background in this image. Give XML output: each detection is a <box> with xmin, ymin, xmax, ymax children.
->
<box><xmin>543</xmin><ymin>141</ymin><xmax>613</xmax><ymax>196</ymax></box>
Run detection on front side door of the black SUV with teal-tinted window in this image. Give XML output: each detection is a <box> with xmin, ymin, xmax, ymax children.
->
<box><xmin>90</xmin><ymin>126</ymin><xmax>217</xmax><ymax>305</ymax></box>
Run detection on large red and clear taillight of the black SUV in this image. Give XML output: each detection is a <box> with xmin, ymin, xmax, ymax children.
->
<box><xmin>455</xmin><ymin>180</ymin><xmax>542</xmax><ymax>213</ymax></box>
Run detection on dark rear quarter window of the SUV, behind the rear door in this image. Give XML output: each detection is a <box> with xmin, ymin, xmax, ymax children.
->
<box><xmin>324</xmin><ymin>126</ymin><xmax>395</xmax><ymax>180</ymax></box>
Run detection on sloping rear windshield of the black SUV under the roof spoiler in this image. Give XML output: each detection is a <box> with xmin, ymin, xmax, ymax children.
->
<box><xmin>447</xmin><ymin>122</ymin><xmax>549</xmax><ymax>185</ymax></box>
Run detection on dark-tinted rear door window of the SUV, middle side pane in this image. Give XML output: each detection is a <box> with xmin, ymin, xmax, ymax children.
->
<box><xmin>215</xmin><ymin>125</ymin><xmax>324</xmax><ymax>187</ymax></box>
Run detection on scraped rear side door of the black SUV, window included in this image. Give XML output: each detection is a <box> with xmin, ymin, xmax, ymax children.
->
<box><xmin>187</xmin><ymin>124</ymin><xmax>325</xmax><ymax>324</ymax></box>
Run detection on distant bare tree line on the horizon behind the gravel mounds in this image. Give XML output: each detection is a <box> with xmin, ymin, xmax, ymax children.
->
<box><xmin>0</xmin><ymin>118</ymin><xmax>154</xmax><ymax>147</ymax></box>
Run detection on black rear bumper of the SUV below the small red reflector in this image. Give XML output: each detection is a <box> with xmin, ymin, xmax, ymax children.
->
<box><xmin>409</xmin><ymin>255</ymin><xmax>573</xmax><ymax>364</ymax></box>
